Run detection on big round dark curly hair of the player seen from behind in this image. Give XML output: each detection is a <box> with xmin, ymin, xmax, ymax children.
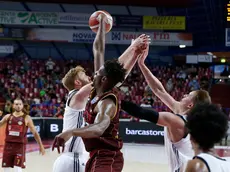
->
<box><xmin>186</xmin><ymin>103</ymin><xmax>228</xmax><ymax>150</ymax></box>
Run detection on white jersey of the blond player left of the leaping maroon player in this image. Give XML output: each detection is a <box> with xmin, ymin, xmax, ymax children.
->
<box><xmin>62</xmin><ymin>90</ymin><xmax>86</xmax><ymax>153</ymax></box>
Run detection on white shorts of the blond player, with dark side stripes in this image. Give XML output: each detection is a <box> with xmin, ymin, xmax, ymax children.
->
<box><xmin>53</xmin><ymin>152</ymin><xmax>88</xmax><ymax>172</ymax></box>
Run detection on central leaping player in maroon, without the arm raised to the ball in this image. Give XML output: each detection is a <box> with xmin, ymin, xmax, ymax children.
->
<box><xmin>54</xmin><ymin>60</ymin><xmax>126</xmax><ymax>172</ymax></box>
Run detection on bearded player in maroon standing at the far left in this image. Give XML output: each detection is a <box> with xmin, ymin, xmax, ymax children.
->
<box><xmin>0</xmin><ymin>98</ymin><xmax>45</xmax><ymax>172</ymax></box>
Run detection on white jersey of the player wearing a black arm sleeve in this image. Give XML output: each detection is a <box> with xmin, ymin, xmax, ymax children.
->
<box><xmin>164</xmin><ymin>115</ymin><xmax>194</xmax><ymax>172</ymax></box>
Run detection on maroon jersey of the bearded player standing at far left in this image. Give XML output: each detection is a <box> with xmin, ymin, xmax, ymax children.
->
<box><xmin>5</xmin><ymin>114</ymin><xmax>28</xmax><ymax>144</ymax></box>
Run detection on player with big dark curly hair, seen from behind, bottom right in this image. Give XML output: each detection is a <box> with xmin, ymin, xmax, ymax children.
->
<box><xmin>185</xmin><ymin>104</ymin><xmax>230</xmax><ymax>172</ymax></box>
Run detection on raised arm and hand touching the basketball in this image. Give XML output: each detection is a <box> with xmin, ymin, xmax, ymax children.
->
<box><xmin>93</xmin><ymin>14</ymin><xmax>107</xmax><ymax>72</ymax></box>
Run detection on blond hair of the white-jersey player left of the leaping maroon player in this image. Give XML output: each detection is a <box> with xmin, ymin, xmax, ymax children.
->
<box><xmin>62</xmin><ymin>66</ymin><xmax>85</xmax><ymax>91</ymax></box>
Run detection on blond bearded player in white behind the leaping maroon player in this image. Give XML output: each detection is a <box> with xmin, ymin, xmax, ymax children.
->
<box><xmin>53</xmin><ymin>66</ymin><xmax>90</xmax><ymax>172</ymax></box>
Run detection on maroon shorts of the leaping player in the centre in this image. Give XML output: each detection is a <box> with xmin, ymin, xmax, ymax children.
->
<box><xmin>85</xmin><ymin>150</ymin><xmax>124</xmax><ymax>172</ymax></box>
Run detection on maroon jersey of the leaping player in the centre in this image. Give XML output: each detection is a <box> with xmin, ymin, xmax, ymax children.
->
<box><xmin>83</xmin><ymin>89</ymin><xmax>123</xmax><ymax>152</ymax></box>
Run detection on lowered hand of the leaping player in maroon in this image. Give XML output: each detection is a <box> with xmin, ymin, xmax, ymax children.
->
<box><xmin>52</xmin><ymin>131</ymin><xmax>72</xmax><ymax>153</ymax></box>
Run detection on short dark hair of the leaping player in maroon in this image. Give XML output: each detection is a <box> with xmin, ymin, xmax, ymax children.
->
<box><xmin>104</xmin><ymin>59</ymin><xmax>126</xmax><ymax>87</ymax></box>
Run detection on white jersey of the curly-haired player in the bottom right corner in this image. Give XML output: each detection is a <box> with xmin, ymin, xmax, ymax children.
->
<box><xmin>193</xmin><ymin>153</ymin><xmax>230</xmax><ymax>172</ymax></box>
